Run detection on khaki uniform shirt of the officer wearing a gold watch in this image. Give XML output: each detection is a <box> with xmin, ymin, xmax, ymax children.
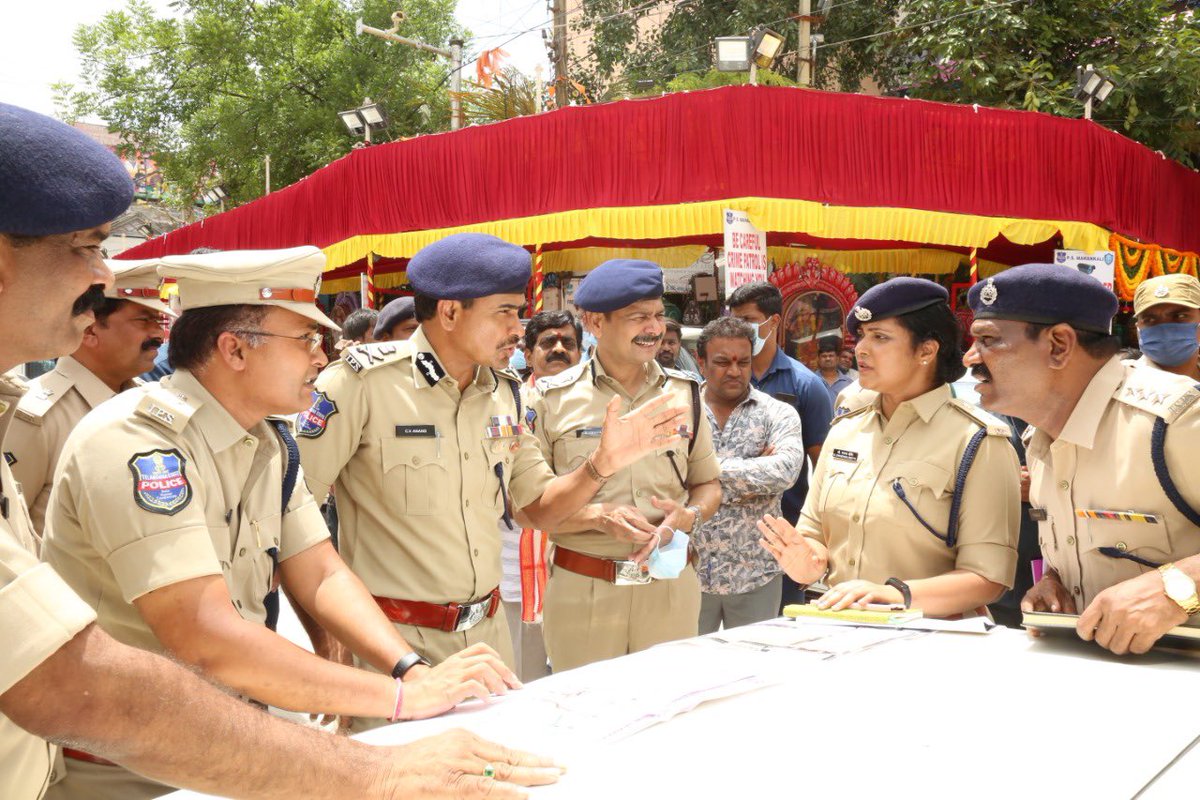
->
<box><xmin>1026</xmin><ymin>357</ymin><xmax>1200</xmax><ymax>612</ymax></box>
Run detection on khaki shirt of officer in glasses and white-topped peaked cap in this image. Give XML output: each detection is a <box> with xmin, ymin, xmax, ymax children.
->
<box><xmin>43</xmin><ymin>369</ymin><xmax>329</xmax><ymax>651</ymax></box>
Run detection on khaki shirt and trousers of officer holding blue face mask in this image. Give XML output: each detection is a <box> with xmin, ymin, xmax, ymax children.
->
<box><xmin>533</xmin><ymin>359</ymin><xmax>720</xmax><ymax>672</ymax></box>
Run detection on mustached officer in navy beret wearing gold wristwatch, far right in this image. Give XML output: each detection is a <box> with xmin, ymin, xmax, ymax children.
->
<box><xmin>966</xmin><ymin>264</ymin><xmax>1200</xmax><ymax>654</ymax></box>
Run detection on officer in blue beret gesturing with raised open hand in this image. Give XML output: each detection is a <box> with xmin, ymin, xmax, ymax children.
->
<box><xmin>298</xmin><ymin>234</ymin><xmax>695</xmax><ymax>690</ymax></box>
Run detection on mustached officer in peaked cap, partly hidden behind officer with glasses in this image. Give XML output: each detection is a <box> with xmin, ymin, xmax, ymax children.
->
<box><xmin>5</xmin><ymin>259</ymin><xmax>172</xmax><ymax>533</ymax></box>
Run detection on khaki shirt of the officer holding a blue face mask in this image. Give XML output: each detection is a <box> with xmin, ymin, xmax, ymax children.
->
<box><xmin>532</xmin><ymin>357</ymin><xmax>721</xmax><ymax>559</ymax></box>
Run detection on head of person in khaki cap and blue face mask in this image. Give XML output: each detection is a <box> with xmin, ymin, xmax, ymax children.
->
<box><xmin>1133</xmin><ymin>273</ymin><xmax>1200</xmax><ymax>381</ymax></box>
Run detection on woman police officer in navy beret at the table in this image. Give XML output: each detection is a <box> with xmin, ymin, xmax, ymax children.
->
<box><xmin>758</xmin><ymin>278</ymin><xmax>1021</xmax><ymax>616</ymax></box>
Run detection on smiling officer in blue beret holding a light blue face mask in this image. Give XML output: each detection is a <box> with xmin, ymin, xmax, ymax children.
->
<box><xmin>533</xmin><ymin>259</ymin><xmax>721</xmax><ymax>670</ymax></box>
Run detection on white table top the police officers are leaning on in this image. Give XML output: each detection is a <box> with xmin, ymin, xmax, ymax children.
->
<box><xmin>172</xmin><ymin>622</ymin><xmax>1200</xmax><ymax>800</ymax></box>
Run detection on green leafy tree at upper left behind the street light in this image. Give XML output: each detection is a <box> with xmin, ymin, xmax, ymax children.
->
<box><xmin>56</xmin><ymin>0</ymin><xmax>461</xmax><ymax>209</ymax></box>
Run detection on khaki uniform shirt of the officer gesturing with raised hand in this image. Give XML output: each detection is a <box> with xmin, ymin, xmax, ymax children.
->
<box><xmin>296</xmin><ymin>329</ymin><xmax>553</xmax><ymax>603</ymax></box>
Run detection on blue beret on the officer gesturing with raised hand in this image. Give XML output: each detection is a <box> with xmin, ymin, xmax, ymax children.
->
<box><xmin>408</xmin><ymin>234</ymin><xmax>533</xmax><ymax>300</ymax></box>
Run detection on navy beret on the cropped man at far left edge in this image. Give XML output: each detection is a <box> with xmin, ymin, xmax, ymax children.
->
<box><xmin>0</xmin><ymin>103</ymin><xmax>133</xmax><ymax>236</ymax></box>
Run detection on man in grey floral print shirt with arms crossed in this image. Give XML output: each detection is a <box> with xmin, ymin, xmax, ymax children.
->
<box><xmin>692</xmin><ymin>317</ymin><xmax>804</xmax><ymax>634</ymax></box>
